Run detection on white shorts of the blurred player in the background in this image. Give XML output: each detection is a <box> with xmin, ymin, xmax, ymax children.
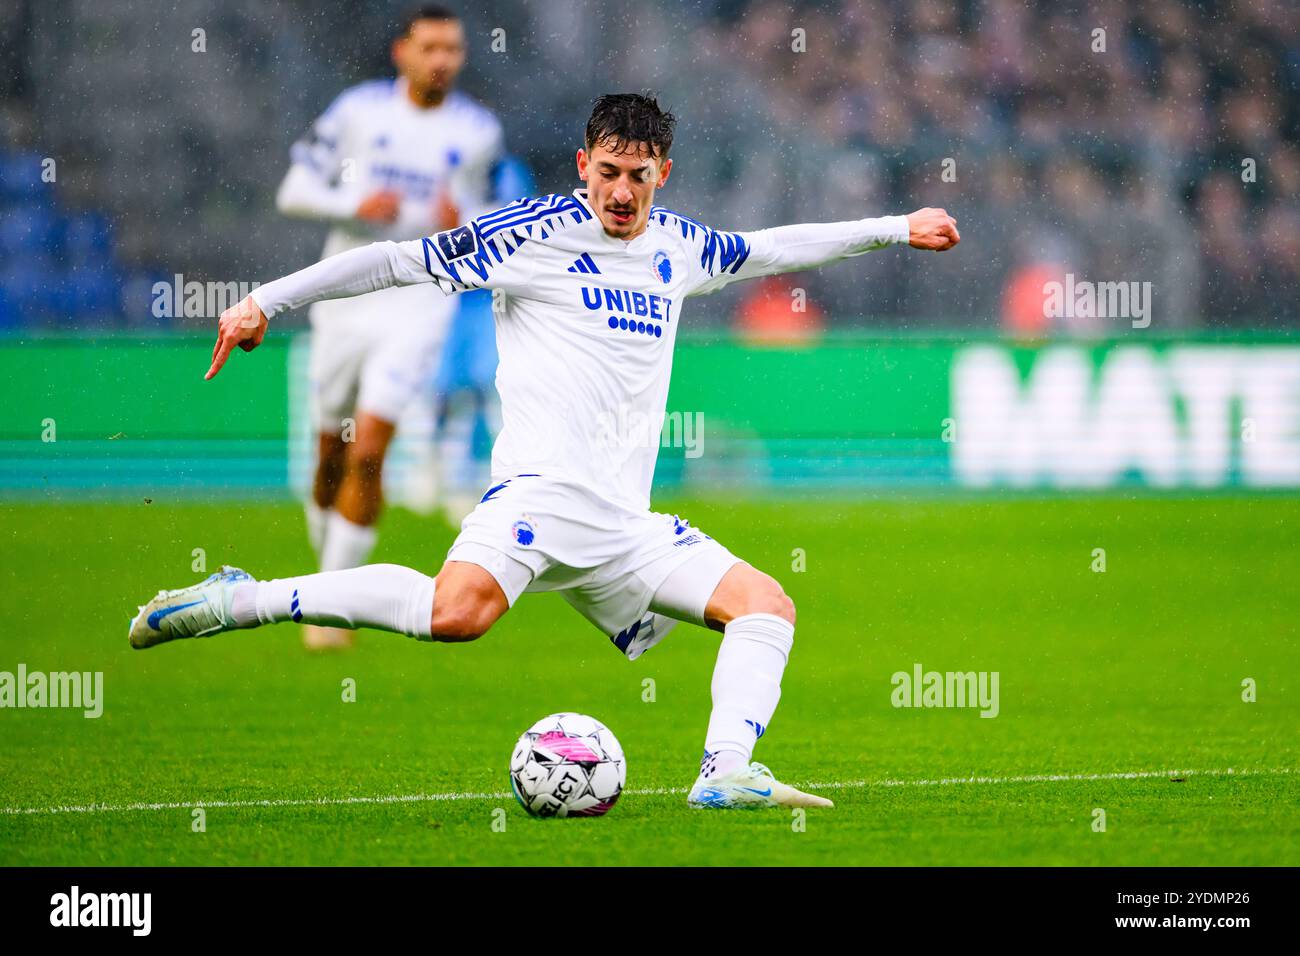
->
<box><xmin>309</xmin><ymin>285</ymin><xmax>456</xmax><ymax>433</ymax></box>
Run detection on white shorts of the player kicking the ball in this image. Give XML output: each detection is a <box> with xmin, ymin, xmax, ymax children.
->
<box><xmin>447</xmin><ymin>475</ymin><xmax>740</xmax><ymax>658</ymax></box>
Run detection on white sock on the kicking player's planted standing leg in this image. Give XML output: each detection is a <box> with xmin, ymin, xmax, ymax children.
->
<box><xmin>701</xmin><ymin>614</ymin><xmax>794</xmax><ymax>777</ymax></box>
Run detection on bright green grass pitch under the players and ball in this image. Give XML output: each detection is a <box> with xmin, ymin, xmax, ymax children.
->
<box><xmin>0</xmin><ymin>496</ymin><xmax>1300</xmax><ymax>866</ymax></box>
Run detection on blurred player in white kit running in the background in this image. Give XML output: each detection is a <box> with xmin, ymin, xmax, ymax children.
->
<box><xmin>276</xmin><ymin>5</ymin><xmax>502</xmax><ymax>649</ymax></box>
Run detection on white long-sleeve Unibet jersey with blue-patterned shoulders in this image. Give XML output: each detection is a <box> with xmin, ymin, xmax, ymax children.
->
<box><xmin>252</xmin><ymin>190</ymin><xmax>909</xmax><ymax>511</ymax></box>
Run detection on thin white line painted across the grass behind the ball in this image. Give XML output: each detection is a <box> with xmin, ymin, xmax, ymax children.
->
<box><xmin>0</xmin><ymin>767</ymin><xmax>1300</xmax><ymax>817</ymax></box>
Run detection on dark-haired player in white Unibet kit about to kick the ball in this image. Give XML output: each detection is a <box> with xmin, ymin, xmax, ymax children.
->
<box><xmin>130</xmin><ymin>94</ymin><xmax>959</xmax><ymax>808</ymax></box>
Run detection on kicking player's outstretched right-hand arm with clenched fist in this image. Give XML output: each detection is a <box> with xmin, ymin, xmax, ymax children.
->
<box><xmin>690</xmin><ymin>208</ymin><xmax>961</xmax><ymax>295</ymax></box>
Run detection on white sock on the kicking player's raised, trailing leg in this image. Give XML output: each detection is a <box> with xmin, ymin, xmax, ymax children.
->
<box><xmin>230</xmin><ymin>564</ymin><xmax>434</xmax><ymax>640</ymax></box>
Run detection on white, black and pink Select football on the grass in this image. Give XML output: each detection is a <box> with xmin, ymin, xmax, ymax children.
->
<box><xmin>510</xmin><ymin>713</ymin><xmax>628</xmax><ymax>817</ymax></box>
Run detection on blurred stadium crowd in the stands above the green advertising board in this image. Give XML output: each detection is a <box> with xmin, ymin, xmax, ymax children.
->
<box><xmin>0</xmin><ymin>0</ymin><xmax>1300</xmax><ymax>334</ymax></box>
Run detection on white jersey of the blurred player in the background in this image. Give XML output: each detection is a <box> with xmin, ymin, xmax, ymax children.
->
<box><xmin>278</xmin><ymin>78</ymin><xmax>503</xmax><ymax>256</ymax></box>
